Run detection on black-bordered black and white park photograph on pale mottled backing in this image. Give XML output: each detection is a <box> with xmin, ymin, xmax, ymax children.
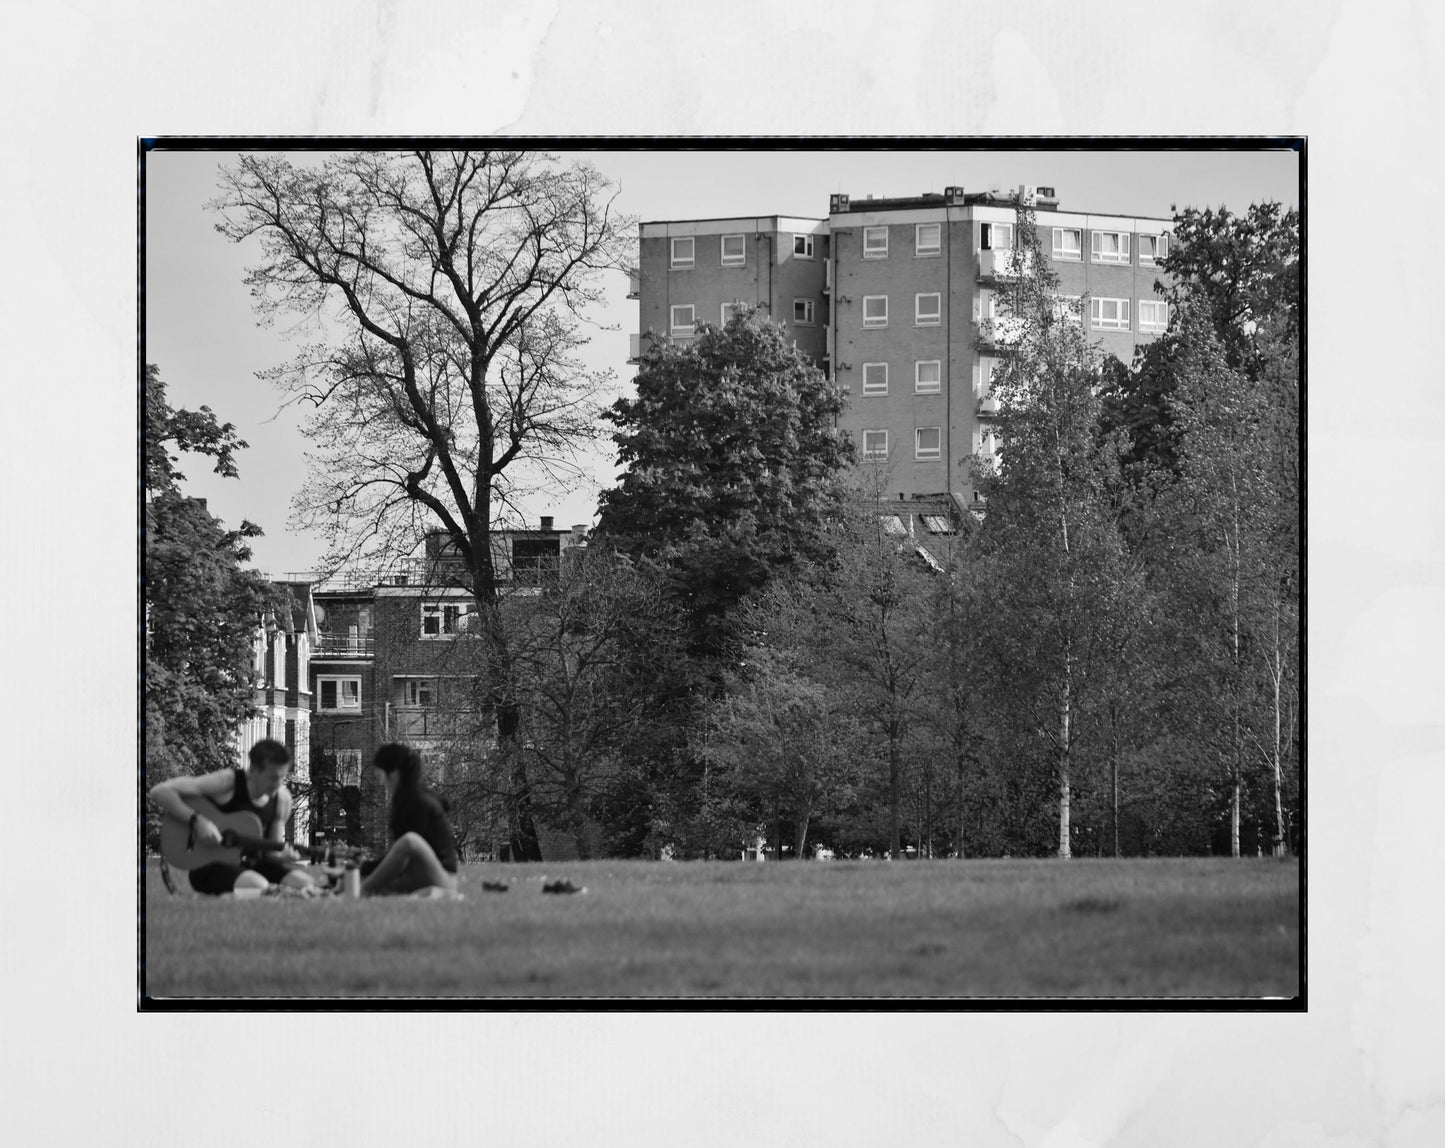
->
<box><xmin>142</xmin><ymin>137</ymin><xmax>1306</xmax><ymax>1008</ymax></box>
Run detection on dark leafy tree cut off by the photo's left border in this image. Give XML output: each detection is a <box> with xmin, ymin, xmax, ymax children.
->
<box><xmin>145</xmin><ymin>363</ymin><xmax>279</xmax><ymax>809</ymax></box>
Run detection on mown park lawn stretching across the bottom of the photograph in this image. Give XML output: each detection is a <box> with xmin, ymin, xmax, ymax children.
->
<box><xmin>143</xmin><ymin>859</ymin><xmax>1301</xmax><ymax>1002</ymax></box>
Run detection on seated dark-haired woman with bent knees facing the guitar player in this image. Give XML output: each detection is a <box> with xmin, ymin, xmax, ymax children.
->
<box><xmin>361</xmin><ymin>742</ymin><xmax>457</xmax><ymax>896</ymax></box>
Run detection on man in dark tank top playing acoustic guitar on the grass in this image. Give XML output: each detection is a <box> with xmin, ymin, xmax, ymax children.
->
<box><xmin>150</xmin><ymin>737</ymin><xmax>315</xmax><ymax>896</ymax></box>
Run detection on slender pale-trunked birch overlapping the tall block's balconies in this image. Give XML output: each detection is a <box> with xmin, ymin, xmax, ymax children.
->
<box><xmin>980</xmin><ymin>211</ymin><xmax>1139</xmax><ymax>857</ymax></box>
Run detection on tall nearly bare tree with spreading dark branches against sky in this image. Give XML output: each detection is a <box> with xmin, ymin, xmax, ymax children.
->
<box><xmin>212</xmin><ymin>150</ymin><xmax>631</xmax><ymax>857</ymax></box>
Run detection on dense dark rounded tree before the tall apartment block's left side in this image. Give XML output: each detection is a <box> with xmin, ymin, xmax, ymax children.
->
<box><xmin>601</xmin><ymin>309</ymin><xmax>853</xmax><ymax>654</ymax></box>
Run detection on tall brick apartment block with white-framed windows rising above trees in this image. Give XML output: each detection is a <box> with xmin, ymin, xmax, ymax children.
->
<box><xmin>633</xmin><ymin>187</ymin><xmax>1172</xmax><ymax>523</ymax></box>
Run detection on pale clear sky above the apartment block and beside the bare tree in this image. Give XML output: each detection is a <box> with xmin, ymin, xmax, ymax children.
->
<box><xmin>145</xmin><ymin>140</ymin><xmax>1299</xmax><ymax>577</ymax></box>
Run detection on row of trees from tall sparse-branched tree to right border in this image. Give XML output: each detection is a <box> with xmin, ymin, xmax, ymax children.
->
<box><xmin>161</xmin><ymin>152</ymin><xmax>1299</xmax><ymax>857</ymax></box>
